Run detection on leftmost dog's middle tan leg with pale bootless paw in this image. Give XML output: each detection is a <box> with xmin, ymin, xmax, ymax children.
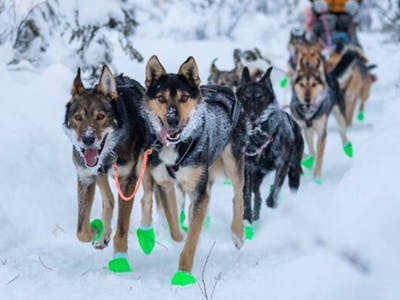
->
<box><xmin>94</xmin><ymin>174</ymin><xmax>114</xmax><ymax>249</ymax></box>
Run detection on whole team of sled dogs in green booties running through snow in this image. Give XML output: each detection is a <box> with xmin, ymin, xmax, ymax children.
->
<box><xmin>64</xmin><ymin>2</ymin><xmax>376</xmax><ymax>286</ymax></box>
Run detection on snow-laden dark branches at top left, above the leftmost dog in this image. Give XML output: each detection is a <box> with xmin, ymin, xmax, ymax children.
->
<box><xmin>9</xmin><ymin>0</ymin><xmax>143</xmax><ymax>78</ymax></box>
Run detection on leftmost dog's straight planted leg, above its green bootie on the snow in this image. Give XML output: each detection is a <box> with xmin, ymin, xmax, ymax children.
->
<box><xmin>114</xmin><ymin>174</ymin><xmax>137</xmax><ymax>254</ymax></box>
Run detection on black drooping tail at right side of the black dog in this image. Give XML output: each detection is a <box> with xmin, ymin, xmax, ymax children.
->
<box><xmin>288</xmin><ymin>116</ymin><xmax>304</xmax><ymax>192</ymax></box>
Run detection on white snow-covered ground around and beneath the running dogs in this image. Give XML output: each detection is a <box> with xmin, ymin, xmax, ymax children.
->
<box><xmin>0</xmin><ymin>9</ymin><xmax>400</xmax><ymax>300</ymax></box>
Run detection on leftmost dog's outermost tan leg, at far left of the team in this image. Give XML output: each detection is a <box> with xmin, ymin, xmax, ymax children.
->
<box><xmin>77</xmin><ymin>177</ymin><xmax>96</xmax><ymax>243</ymax></box>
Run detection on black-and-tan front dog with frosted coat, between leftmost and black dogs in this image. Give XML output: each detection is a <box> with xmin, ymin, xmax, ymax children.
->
<box><xmin>142</xmin><ymin>56</ymin><xmax>247</xmax><ymax>285</ymax></box>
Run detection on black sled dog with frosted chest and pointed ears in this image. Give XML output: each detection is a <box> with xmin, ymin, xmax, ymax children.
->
<box><xmin>237</xmin><ymin>67</ymin><xmax>304</xmax><ymax>232</ymax></box>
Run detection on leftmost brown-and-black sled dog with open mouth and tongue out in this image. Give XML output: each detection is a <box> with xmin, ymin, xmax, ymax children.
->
<box><xmin>64</xmin><ymin>66</ymin><xmax>151</xmax><ymax>271</ymax></box>
